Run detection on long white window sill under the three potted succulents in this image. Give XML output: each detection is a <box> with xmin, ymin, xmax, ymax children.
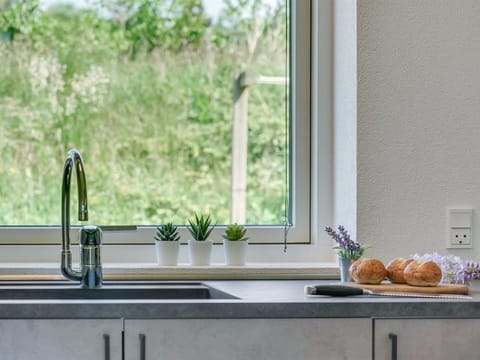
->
<box><xmin>0</xmin><ymin>263</ymin><xmax>339</xmax><ymax>281</ymax></box>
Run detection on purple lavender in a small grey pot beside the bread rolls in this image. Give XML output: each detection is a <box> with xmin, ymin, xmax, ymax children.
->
<box><xmin>325</xmin><ymin>225</ymin><xmax>367</xmax><ymax>282</ymax></box>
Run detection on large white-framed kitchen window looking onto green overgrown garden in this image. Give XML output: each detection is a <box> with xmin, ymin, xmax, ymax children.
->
<box><xmin>0</xmin><ymin>0</ymin><xmax>324</xmax><ymax>262</ymax></box>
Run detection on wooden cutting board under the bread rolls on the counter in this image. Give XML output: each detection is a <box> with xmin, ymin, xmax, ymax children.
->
<box><xmin>348</xmin><ymin>282</ymin><xmax>468</xmax><ymax>295</ymax></box>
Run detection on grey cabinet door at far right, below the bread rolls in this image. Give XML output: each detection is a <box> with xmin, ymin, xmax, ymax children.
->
<box><xmin>374</xmin><ymin>319</ymin><xmax>480</xmax><ymax>360</ymax></box>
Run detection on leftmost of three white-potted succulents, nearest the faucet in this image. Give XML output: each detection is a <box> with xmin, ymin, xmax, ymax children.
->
<box><xmin>154</xmin><ymin>222</ymin><xmax>180</xmax><ymax>266</ymax></box>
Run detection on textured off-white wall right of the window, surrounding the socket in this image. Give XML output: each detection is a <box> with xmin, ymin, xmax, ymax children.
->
<box><xmin>357</xmin><ymin>0</ymin><xmax>480</xmax><ymax>261</ymax></box>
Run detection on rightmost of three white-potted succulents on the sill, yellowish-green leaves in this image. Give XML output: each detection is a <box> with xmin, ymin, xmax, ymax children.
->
<box><xmin>222</xmin><ymin>223</ymin><xmax>248</xmax><ymax>265</ymax></box>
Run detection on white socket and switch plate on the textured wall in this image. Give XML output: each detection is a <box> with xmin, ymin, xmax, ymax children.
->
<box><xmin>447</xmin><ymin>209</ymin><xmax>473</xmax><ymax>249</ymax></box>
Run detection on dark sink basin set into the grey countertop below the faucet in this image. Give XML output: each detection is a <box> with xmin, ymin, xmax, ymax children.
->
<box><xmin>0</xmin><ymin>282</ymin><xmax>238</xmax><ymax>300</ymax></box>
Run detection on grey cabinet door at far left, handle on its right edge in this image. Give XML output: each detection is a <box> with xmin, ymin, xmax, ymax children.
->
<box><xmin>0</xmin><ymin>319</ymin><xmax>122</xmax><ymax>360</ymax></box>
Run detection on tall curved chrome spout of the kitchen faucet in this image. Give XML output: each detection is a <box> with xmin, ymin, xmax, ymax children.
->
<box><xmin>61</xmin><ymin>149</ymin><xmax>88</xmax><ymax>281</ymax></box>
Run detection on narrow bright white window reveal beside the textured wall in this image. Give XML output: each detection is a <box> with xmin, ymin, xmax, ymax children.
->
<box><xmin>333</xmin><ymin>0</ymin><xmax>357</xmax><ymax>239</ymax></box>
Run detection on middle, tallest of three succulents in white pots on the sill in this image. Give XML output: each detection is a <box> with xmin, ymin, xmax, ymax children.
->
<box><xmin>187</xmin><ymin>214</ymin><xmax>215</xmax><ymax>266</ymax></box>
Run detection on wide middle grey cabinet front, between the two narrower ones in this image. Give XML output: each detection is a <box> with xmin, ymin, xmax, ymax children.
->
<box><xmin>125</xmin><ymin>319</ymin><xmax>372</xmax><ymax>360</ymax></box>
